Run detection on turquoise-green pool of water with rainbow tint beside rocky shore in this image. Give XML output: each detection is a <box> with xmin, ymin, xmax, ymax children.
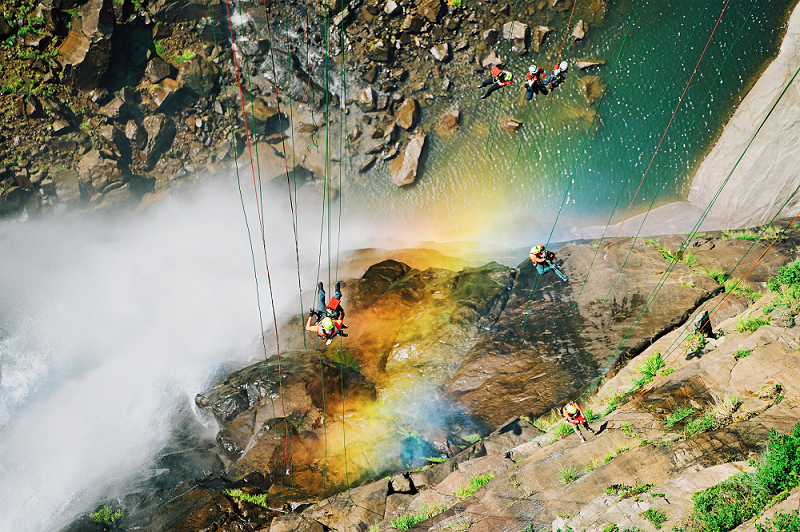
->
<box><xmin>345</xmin><ymin>0</ymin><xmax>795</xmax><ymax>243</ymax></box>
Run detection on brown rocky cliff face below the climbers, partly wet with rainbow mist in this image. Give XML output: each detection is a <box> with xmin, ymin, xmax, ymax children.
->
<box><xmin>59</xmin><ymin>222</ymin><xmax>800</xmax><ymax>532</ymax></box>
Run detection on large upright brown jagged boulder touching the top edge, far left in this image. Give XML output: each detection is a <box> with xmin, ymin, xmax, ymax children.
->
<box><xmin>57</xmin><ymin>0</ymin><xmax>114</xmax><ymax>90</ymax></box>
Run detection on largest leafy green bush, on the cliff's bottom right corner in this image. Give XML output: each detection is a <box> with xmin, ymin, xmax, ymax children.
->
<box><xmin>692</xmin><ymin>423</ymin><xmax>800</xmax><ymax>532</ymax></box>
